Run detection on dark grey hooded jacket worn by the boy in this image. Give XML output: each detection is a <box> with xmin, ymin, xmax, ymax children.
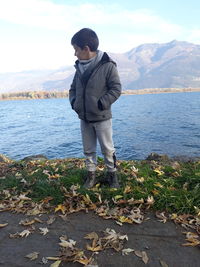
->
<box><xmin>69</xmin><ymin>53</ymin><xmax>121</xmax><ymax>122</ymax></box>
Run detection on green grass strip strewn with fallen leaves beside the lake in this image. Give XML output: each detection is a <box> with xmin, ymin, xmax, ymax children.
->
<box><xmin>0</xmin><ymin>158</ymin><xmax>200</xmax><ymax>214</ymax></box>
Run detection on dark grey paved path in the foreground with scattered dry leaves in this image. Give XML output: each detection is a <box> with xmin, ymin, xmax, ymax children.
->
<box><xmin>0</xmin><ymin>212</ymin><xmax>200</xmax><ymax>267</ymax></box>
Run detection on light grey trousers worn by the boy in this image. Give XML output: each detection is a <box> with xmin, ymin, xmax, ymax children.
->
<box><xmin>81</xmin><ymin>119</ymin><xmax>116</xmax><ymax>172</ymax></box>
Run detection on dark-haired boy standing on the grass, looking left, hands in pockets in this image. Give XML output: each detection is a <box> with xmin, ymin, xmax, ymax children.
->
<box><xmin>69</xmin><ymin>28</ymin><xmax>121</xmax><ymax>189</ymax></box>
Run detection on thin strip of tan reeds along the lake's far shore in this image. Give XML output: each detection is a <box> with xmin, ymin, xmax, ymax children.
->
<box><xmin>0</xmin><ymin>88</ymin><xmax>200</xmax><ymax>101</ymax></box>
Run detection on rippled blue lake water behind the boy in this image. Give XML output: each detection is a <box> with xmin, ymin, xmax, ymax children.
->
<box><xmin>0</xmin><ymin>93</ymin><xmax>200</xmax><ymax>159</ymax></box>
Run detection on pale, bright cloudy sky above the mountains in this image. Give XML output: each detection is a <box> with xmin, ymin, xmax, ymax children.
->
<box><xmin>0</xmin><ymin>0</ymin><xmax>200</xmax><ymax>73</ymax></box>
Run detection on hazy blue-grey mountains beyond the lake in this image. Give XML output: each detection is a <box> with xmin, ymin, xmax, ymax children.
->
<box><xmin>0</xmin><ymin>40</ymin><xmax>200</xmax><ymax>93</ymax></box>
